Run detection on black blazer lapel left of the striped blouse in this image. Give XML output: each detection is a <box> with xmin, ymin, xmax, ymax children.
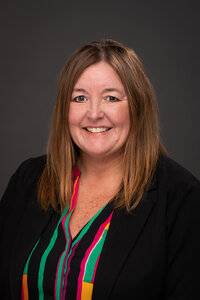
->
<box><xmin>10</xmin><ymin>192</ymin><xmax>53</xmax><ymax>299</ymax></box>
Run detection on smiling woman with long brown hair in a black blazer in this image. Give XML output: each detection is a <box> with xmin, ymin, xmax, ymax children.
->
<box><xmin>0</xmin><ymin>39</ymin><xmax>200</xmax><ymax>300</ymax></box>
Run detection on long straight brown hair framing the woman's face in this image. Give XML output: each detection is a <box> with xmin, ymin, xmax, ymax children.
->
<box><xmin>38</xmin><ymin>39</ymin><xmax>167</xmax><ymax>211</ymax></box>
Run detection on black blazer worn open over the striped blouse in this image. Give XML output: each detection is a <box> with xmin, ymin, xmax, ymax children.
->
<box><xmin>0</xmin><ymin>156</ymin><xmax>200</xmax><ymax>300</ymax></box>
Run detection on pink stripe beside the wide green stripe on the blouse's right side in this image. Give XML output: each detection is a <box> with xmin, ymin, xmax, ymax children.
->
<box><xmin>76</xmin><ymin>213</ymin><xmax>112</xmax><ymax>300</ymax></box>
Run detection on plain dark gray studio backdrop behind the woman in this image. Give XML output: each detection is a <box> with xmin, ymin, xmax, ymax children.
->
<box><xmin>0</xmin><ymin>0</ymin><xmax>200</xmax><ymax>197</ymax></box>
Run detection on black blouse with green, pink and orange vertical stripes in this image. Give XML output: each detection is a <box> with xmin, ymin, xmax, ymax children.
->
<box><xmin>21</xmin><ymin>168</ymin><xmax>113</xmax><ymax>300</ymax></box>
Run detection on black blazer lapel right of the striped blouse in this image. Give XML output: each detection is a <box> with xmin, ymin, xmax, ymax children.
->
<box><xmin>93</xmin><ymin>176</ymin><xmax>157</xmax><ymax>300</ymax></box>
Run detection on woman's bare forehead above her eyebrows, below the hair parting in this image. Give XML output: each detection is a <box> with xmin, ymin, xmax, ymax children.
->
<box><xmin>74</xmin><ymin>62</ymin><xmax>124</xmax><ymax>90</ymax></box>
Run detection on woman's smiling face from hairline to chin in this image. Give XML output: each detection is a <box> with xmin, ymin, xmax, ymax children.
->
<box><xmin>69</xmin><ymin>62</ymin><xmax>130</xmax><ymax>158</ymax></box>
